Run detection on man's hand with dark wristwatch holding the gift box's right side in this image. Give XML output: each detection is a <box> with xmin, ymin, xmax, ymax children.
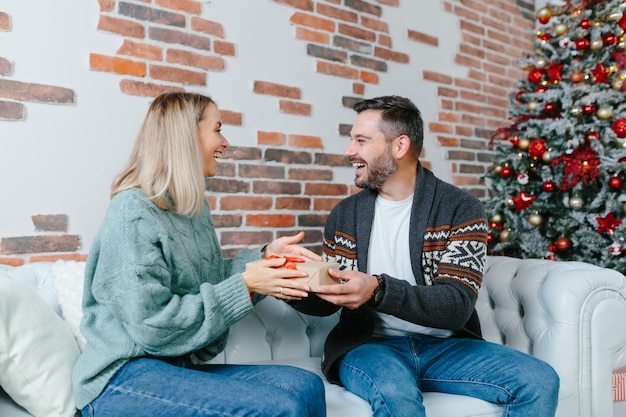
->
<box><xmin>317</xmin><ymin>269</ymin><xmax>378</xmax><ymax>309</ymax></box>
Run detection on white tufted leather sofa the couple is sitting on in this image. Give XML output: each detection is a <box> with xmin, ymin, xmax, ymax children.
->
<box><xmin>0</xmin><ymin>257</ymin><xmax>626</xmax><ymax>417</ymax></box>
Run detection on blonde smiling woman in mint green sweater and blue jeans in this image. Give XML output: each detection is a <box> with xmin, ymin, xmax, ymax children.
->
<box><xmin>73</xmin><ymin>93</ymin><xmax>326</xmax><ymax>417</ymax></box>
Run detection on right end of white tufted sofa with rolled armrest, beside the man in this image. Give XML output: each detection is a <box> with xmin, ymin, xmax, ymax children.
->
<box><xmin>476</xmin><ymin>256</ymin><xmax>626</xmax><ymax>417</ymax></box>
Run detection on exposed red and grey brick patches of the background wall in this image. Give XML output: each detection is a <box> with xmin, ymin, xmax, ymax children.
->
<box><xmin>0</xmin><ymin>0</ymin><xmax>534</xmax><ymax>264</ymax></box>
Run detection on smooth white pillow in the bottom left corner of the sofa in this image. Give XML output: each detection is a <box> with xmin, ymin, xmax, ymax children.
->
<box><xmin>0</xmin><ymin>271</ymin><xmax>80</xmax><ymax>417</ymax></box>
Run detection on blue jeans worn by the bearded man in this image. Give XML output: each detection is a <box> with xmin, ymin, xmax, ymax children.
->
<box><xmin>339</xmin><ymin>336</ymin><xmax>559</xmax><ymax>417</ymax></box>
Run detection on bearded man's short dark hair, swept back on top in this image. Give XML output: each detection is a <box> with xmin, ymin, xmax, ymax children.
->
<box><xmin>353</xmin><ymin>96</ymin><xmax>424</xmax><ymax>157</ymax></box>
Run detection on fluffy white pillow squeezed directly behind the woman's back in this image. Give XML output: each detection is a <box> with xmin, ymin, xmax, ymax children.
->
<box><xmin>50</xmin><ymin>260</ymin><xmax>86</xmax><ymax>351</ymax></box>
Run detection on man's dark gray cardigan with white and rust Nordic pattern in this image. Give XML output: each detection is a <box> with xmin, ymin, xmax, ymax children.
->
<box><xmin>291</xmin><ymin>164</ymin><xmax>488</xmax><ymax>384</ymax></box>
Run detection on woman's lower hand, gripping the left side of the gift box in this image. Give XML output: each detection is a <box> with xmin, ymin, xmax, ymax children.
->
<box><xmin>241</xmin><ymin>257</ymin><xmax>311</xmax><ymax>301</ymax></box>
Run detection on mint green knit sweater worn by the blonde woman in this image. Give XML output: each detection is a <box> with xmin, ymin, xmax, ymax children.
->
<box><xmin>73</xmin><ymin>190</ymin><xmax>261</xmax><ymax>409</ymax></box>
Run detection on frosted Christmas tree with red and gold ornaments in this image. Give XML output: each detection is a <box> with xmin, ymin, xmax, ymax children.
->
<box><xmin>483</xmin><ymin>0</ymin><xmax>626</xmax><ymax>273</ymax></box>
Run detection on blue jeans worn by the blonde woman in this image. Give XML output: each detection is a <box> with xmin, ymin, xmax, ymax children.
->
<box><xmin>81</xmin><ymin>358</ymin><xmax>326</xmax><ymax>417</ymax></box>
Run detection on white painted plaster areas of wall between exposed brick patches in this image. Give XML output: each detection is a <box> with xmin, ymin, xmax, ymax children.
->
<box><xmin>0</xmin><ymin>0</ymin><xmax>467</xmax><ymax>252</ymax></box>
